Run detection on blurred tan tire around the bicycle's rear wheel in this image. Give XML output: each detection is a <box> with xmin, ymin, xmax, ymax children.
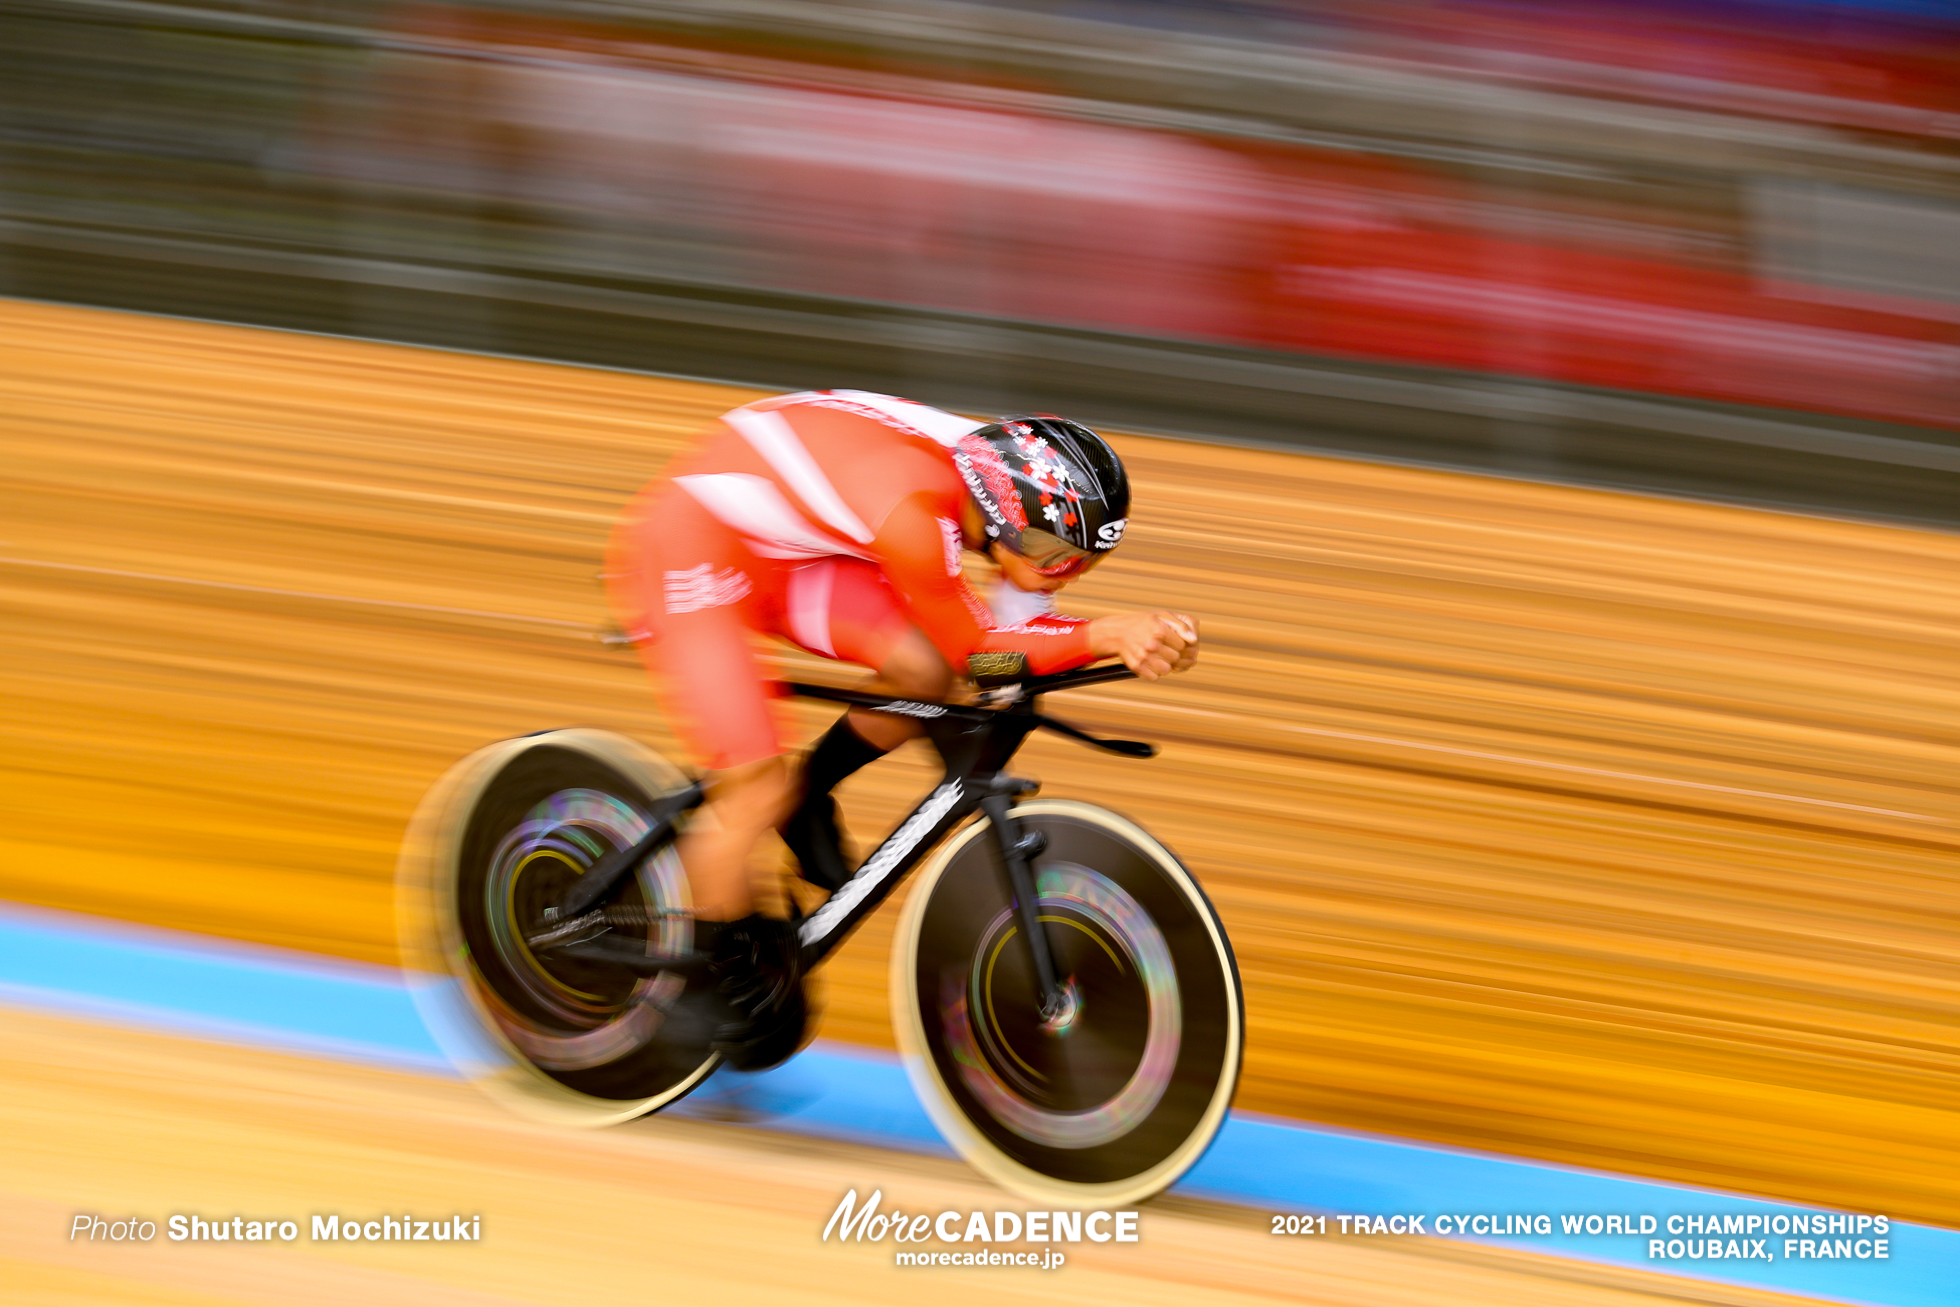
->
<box><xmin>396</xmin><ymin>727</ymin><xmax>719</xmax><ymax>1127</ymax></box>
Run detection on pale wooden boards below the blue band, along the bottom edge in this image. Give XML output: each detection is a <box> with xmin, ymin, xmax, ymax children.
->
<box><xmin>0</xmin><ymin>1011</ymin><xmax>1834</xmax><ymax>1307</ymax></box>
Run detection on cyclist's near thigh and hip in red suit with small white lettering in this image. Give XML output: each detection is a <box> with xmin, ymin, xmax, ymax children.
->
<box><xmin>606</xmin><ymin>484</ymin><xmax>782</xmax><ymax>770</ymax></box>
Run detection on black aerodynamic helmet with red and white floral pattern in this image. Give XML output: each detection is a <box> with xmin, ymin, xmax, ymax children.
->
<box><xmin>953</xmin><ymin>413</ymin><xmax>1129</xmax><ymax>576</ymax></box>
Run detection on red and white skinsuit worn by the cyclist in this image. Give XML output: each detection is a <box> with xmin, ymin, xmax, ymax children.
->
<box><xmin>606</xmin><ymin>390</ymin><xmax>1092</xmax><ymax>770</ymax></box>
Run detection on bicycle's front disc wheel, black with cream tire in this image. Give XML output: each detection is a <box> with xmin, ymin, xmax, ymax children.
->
<box><xmin>892</xmin><ymin>799</ymin><xmax>1245</xmax><ymax>1205</ymax></box>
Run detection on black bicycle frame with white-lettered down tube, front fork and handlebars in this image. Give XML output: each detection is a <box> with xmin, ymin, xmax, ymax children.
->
<box><xmin>784</xmin><ymin>666</ymin><xmax>1156</xmax><ymax>1011</ymax></box>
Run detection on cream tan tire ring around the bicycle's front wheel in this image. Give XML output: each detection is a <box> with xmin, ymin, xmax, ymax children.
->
<box><xmin>890</xmin><ymin>799</ymin><xmax>1245</xmax><ymax>1207</ymax></box>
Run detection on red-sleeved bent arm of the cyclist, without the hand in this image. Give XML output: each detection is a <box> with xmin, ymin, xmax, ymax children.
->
<box><xmin>872</xmin><ymin>492</ymin><xmax>1096</xmax><ymax>676</ymax></box>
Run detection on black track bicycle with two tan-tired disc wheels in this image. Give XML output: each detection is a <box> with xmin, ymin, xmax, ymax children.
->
<box><xmin>400</xmin><ymin>666</ymin><xmax>1245</xmax><ymax>1205</ymax></box>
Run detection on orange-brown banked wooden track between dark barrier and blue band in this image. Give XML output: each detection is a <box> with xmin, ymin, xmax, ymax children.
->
<box><xmin>0</xmin><ymin>302</ymin><xmax>1960</xmax><ymax>1293</ymax></box>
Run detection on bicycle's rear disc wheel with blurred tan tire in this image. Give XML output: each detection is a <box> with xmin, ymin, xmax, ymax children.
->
<box><xmin>402</xmin><ymin>731</ymin><xmax>717</xmax><ymax>1125</ymax></box>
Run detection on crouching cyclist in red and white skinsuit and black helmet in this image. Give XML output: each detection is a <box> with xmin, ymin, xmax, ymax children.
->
<box><xmin>606</xmin><ymin>390</ymin><xmax>1198</xmax><ymax>1070</ymax></box>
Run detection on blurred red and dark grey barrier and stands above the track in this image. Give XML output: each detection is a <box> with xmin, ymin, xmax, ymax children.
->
<box><xmin>0</xmin><ymin>0</ymin><xmax>1960</xmax><ymax>521</ymax></box>
